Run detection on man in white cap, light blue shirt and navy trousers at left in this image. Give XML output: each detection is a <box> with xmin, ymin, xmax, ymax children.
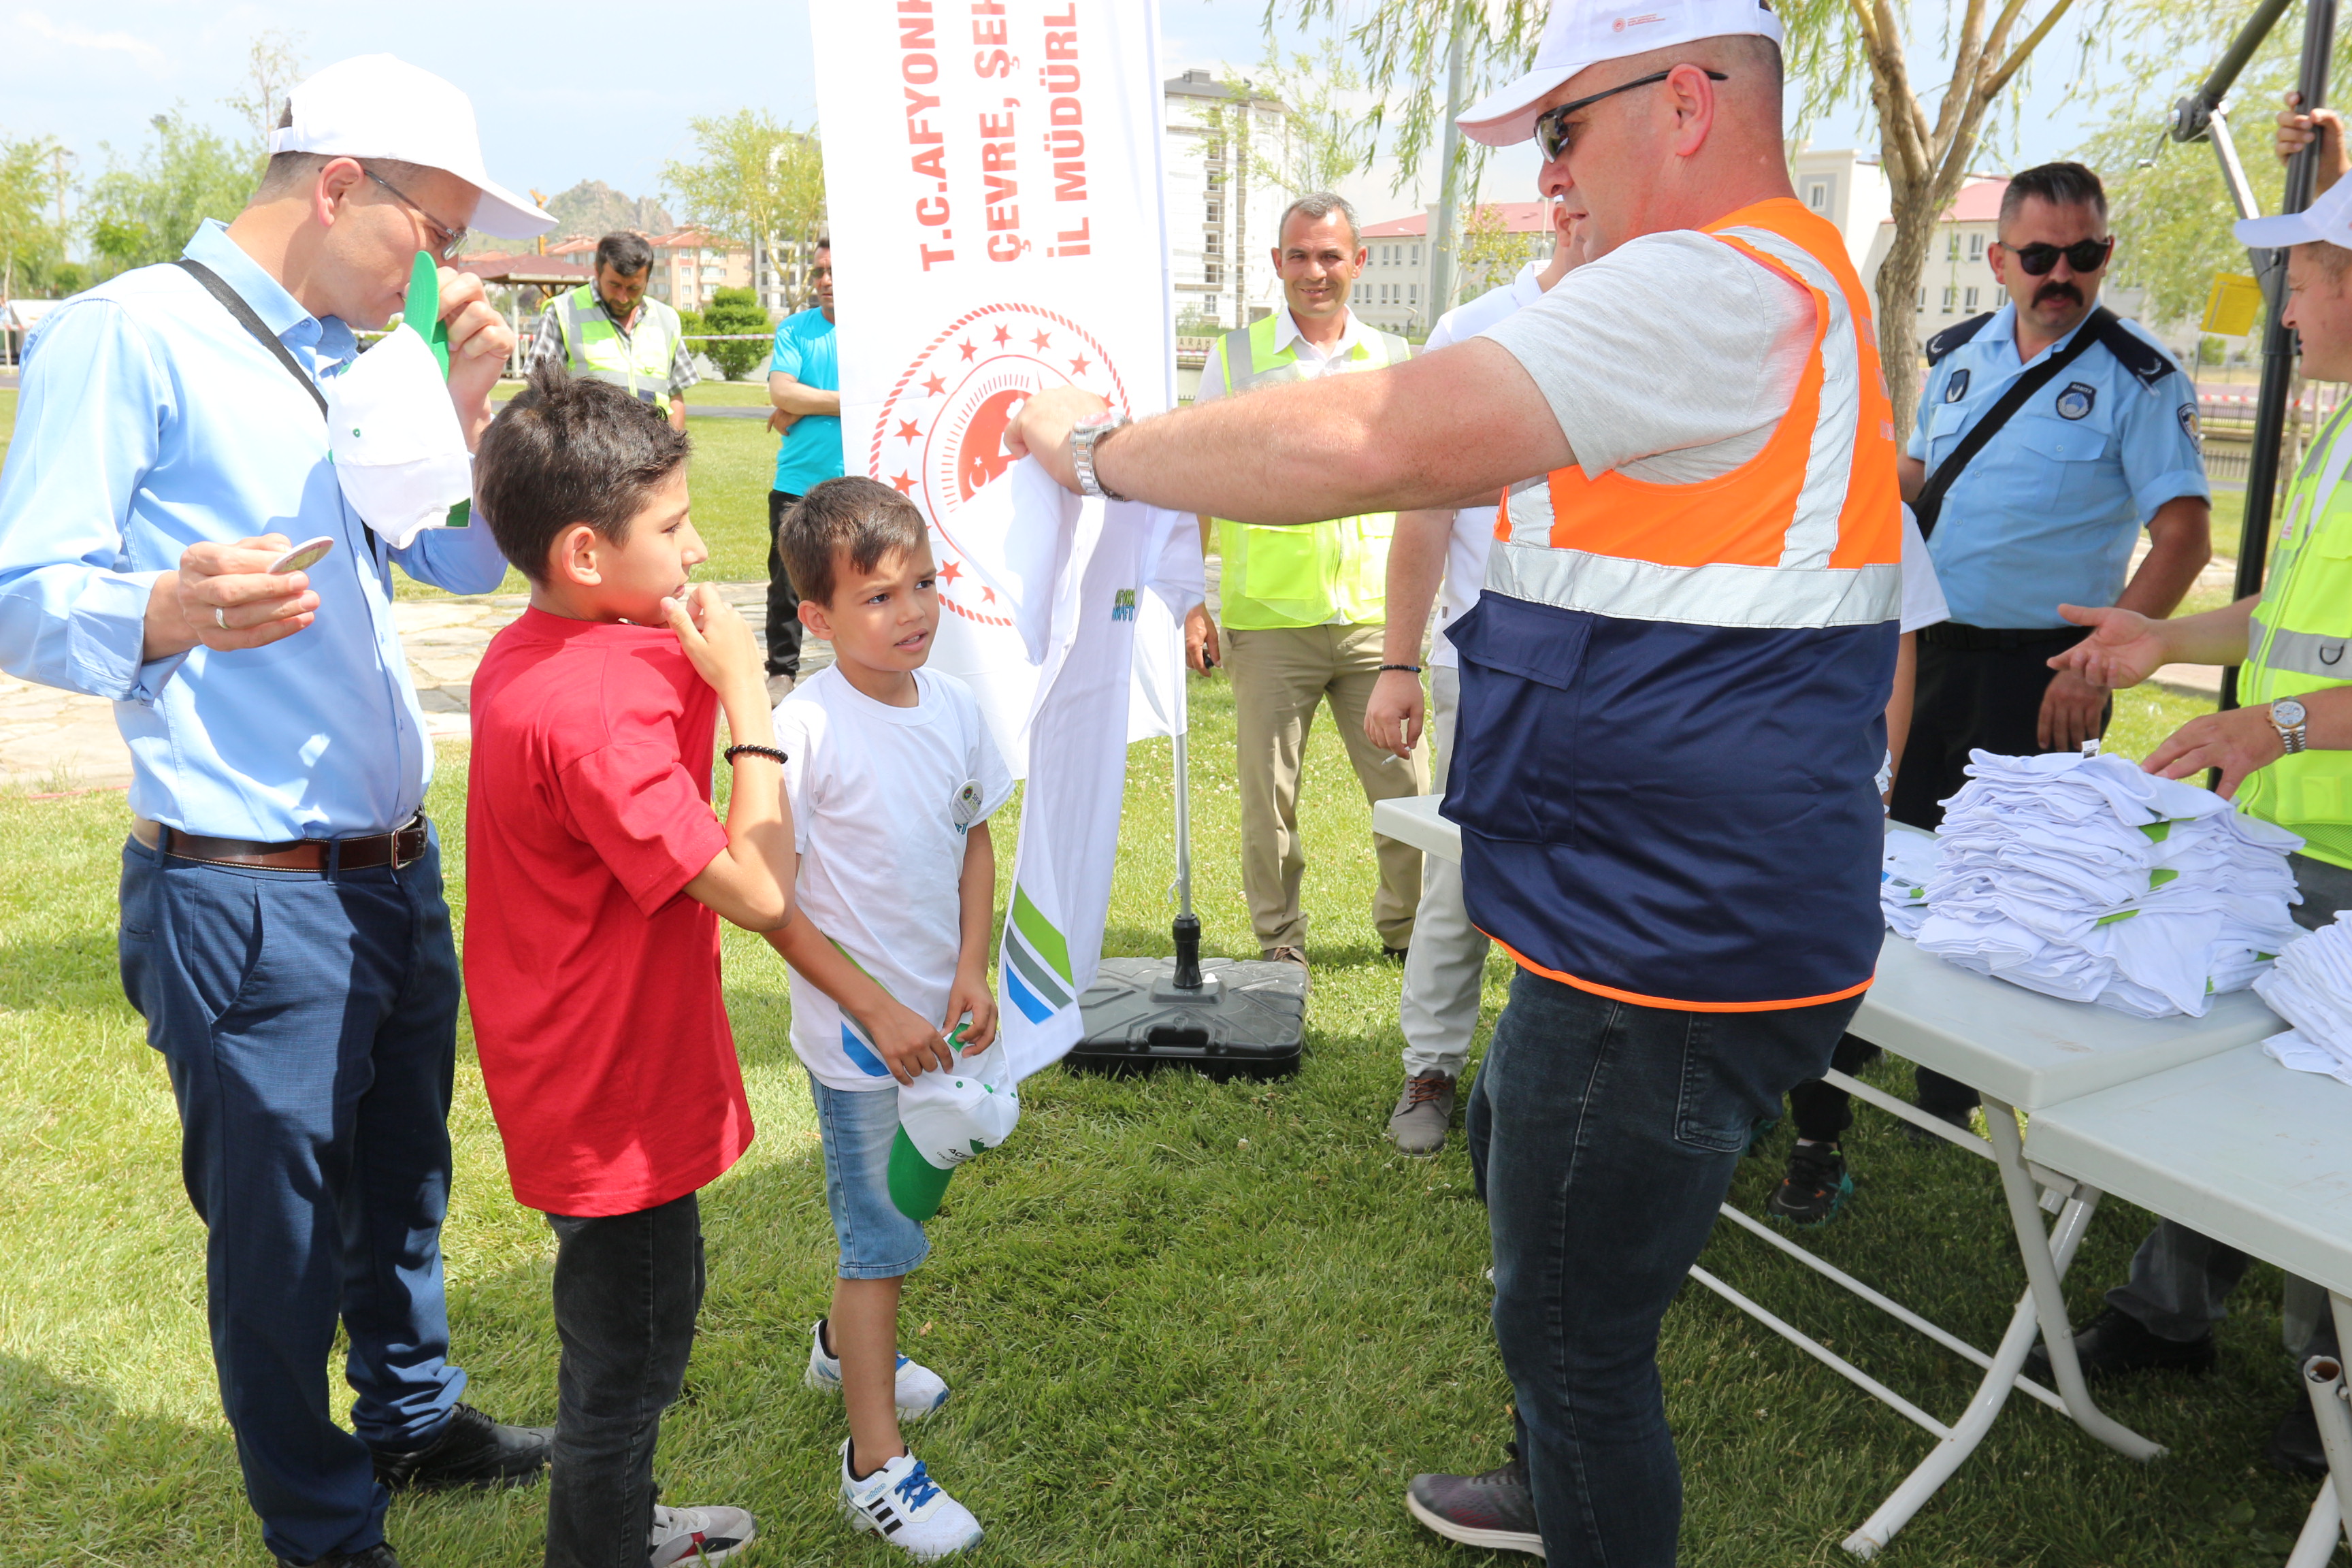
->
<box><xmin>0</xmin><ymin>54</ymin><xmax>548</xmax><ymax>1568</ymax></box>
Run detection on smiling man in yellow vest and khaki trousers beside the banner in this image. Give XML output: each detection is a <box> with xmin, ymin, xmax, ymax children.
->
<box><xmin>1186</xmin><ymin>193</ymin><xmax>1430</xmax><ymax>964</ymax></box>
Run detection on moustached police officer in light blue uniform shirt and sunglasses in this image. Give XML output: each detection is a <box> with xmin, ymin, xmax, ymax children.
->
<box><xmin>1771</xmin><ymin>162</ymin><xmax>2213</xmax><ymax>1225</ymax></box>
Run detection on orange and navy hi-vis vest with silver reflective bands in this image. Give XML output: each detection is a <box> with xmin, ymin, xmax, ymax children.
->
<box><xmin>1444</xmin><ymin>197</ymin><xmax>1903</xmax><ymax>1011</ymax></box>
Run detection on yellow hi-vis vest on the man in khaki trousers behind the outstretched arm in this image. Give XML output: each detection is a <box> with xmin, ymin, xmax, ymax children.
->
<box><xmin>1202</xmin><ymin>315</ymin><xmax>1414</xmax><ymax>632</ymax></box>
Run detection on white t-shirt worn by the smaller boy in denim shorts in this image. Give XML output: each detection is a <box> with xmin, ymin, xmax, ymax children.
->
<box><xmin>776</xmin><ymin>666</ymin><xmax>1014</xmax><ymax>1088</ymax></box>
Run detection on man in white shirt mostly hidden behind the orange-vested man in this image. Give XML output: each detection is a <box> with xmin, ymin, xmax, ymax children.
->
<box><xmin>1364</xmin><ymin>200</ymin><xmax>1583</xmax><ymax>1157</ymax></box>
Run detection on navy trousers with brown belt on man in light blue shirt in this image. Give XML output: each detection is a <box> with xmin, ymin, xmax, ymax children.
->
<box><xmin>120</xmin><ymin>834</ymin><xmax>466</xmax><ymax>1563</ymax></box>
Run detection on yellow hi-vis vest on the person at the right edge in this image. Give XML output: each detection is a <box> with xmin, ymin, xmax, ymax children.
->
<box><xmin>2237</xmin><ymin>407</ymin><xmax>2352</xmax><ymax>868</ymax></box>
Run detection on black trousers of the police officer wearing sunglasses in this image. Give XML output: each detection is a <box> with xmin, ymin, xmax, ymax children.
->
<box><xmin>1891</xmin><ymin>623</ymin><xmax>2114</xmax><ymax>1117</ymax></box>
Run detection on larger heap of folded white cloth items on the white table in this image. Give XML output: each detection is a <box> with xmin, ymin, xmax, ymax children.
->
<box><xmin>1910</xmin><ymin>752</ymin><xmax>2302</xmax><ymax>1018</ymax></box>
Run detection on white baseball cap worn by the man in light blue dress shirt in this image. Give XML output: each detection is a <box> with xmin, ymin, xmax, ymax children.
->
<box><xmin>270</xmin><ymin>54</ymin><xmax>555</xmax><ymax>240</ymax></box>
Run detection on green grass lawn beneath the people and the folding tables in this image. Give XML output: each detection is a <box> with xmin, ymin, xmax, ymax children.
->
<box><xmin>0</xmin><ymin>679</ymin><xmax>2312</xmax><ymax>1568</ymax></box>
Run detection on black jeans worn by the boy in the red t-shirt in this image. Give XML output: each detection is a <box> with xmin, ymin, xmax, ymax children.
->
<box><xmin>548</xmin><ymin>1192</ymin><xmax>703</xmax><ymax>1568</ymax></box>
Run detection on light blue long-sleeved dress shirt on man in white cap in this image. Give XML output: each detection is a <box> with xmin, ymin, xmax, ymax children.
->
<box><xmin>0</xmin><ymin>221</ymin><xmax>506</xmax><ymax>842</ymax></box>
